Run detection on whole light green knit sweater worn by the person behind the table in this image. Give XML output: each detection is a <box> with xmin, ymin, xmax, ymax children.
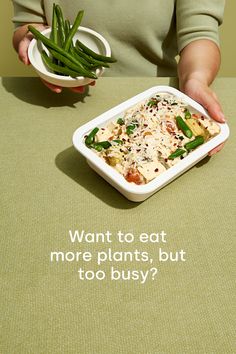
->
<box><xmin>13</xmin><ymin>0</ymin><xmax>225</xmax><ymax>76</ymax></box>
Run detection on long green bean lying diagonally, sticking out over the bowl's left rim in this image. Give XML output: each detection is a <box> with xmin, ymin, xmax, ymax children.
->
<box><xmin>28</xmin><ymin>25</ymin><xmax>97</xmax><ymax>79</ymax></box>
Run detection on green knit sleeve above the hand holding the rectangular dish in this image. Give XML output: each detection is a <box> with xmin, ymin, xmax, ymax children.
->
<box><xmin>176</xmin><ymin>0</ymin><xmax>225</xmax><ymax>52</ymax></box>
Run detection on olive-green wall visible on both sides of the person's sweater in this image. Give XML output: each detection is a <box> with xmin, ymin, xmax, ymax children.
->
<box><xmin>0</xmin><ymin>0</ymin><xmax>236</xmax><ymax>76</ymax></box>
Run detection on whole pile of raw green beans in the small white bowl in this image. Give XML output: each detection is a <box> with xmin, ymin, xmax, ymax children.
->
<box><xmin>28</xmin><ymin>4</ymin><xmax>116</xmax><ymax>79</ymax></box>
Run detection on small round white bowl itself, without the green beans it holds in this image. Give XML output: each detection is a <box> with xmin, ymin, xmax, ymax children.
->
<box><xmin>28</xmin><ymin>26</ymin><xmax>111</xmax><ymax>87</ymax></box>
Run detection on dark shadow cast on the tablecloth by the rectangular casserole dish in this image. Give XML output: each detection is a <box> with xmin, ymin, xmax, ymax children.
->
<box><xmin>55</xmin><ymin>146</ymin><xmax>140</xmax><ymax>209</ymax></box>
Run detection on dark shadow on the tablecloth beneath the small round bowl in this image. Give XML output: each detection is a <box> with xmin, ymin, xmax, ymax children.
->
<box><xmin>2</xmin><ymin>77</ymin><xmax>90</xmax><ymax>108</ymax></box>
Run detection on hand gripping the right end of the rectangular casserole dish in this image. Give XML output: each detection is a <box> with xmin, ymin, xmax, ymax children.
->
<box><xmin>182</xmin><ymin>79</ymin><xmax>226</xmax><ymax>156</ymax></box>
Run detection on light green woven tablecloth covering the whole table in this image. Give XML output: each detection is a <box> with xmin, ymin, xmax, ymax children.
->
<box><xmin>0</xmin><ymin>78</ymin><xmax>236</xmax><ymax>354</ymax></box>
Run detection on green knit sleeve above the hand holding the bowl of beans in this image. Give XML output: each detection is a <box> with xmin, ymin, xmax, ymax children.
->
<box><xmin>12</xmin><ymin>0</ymin><xmax>46</xmax><ymax>28</ymax></box>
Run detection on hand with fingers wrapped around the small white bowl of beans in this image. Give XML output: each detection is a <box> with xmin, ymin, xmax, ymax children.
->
<box><xmin>13</xmin><ymin>23</ymin><xmax>95</xmax><ymax>93</ymax></box>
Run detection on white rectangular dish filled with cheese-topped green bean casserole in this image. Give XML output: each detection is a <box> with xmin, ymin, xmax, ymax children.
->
<box><xmin>73</xmin><ymin>86</ymin><xmax>229</xmax><ymax>201</ymax></box>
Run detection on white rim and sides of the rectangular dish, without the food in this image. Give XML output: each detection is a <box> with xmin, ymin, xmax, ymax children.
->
<box><xmin>73</xmin><ymin>86</ymin><xmax>229</xmax><ymax>202</ymax></box>
